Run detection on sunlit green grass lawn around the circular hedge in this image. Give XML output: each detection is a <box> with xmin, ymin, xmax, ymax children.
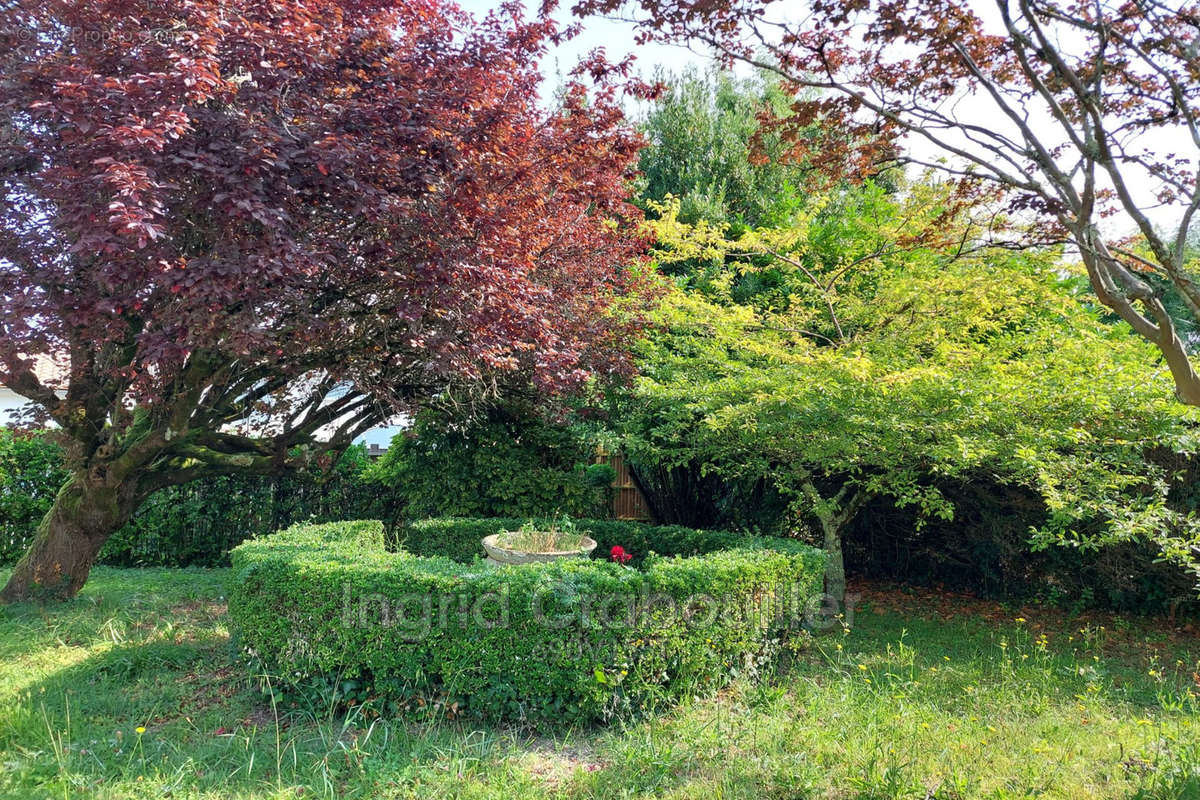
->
<box><xmin>0</xmin><ymin>569</ymin><xmax>1200</xmax><ymax>800</ymax></box>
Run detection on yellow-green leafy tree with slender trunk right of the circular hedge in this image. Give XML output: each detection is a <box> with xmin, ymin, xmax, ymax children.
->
<box><xmin>619</xmin><ymin>185</ymin><xmax>1198</xmax><ymax>597</ymax></box>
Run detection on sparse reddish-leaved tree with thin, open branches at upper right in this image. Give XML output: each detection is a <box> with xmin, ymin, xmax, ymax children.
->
<box><xmin>574</xmin><ymin>0</ymin><xmax>1200</xmax><ymax>405</ymax></box>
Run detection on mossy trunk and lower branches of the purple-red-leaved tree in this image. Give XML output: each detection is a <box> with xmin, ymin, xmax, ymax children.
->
<box><xmin>0</xmin><ymin>391</ymin><xmax>380</xmax><ymax>603</ymax></box>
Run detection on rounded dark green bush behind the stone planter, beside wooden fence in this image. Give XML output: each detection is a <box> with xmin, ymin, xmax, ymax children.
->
<box><xmin>372</xmin><ymin>407</ymin><xmax>613</xmax><ymax>518</ymax></box>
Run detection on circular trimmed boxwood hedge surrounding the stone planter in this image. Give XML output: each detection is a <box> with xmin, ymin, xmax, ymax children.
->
<box><xmin>229</xmin><ymin>519</ymin><xmax>823</xmax><ymax>723</ymax></box>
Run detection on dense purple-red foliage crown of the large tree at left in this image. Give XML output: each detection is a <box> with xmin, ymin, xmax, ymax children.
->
<box><xmin>0</xmin><ymin>0</ymin><xmax>642</xmax><ymax>597</ymax></box>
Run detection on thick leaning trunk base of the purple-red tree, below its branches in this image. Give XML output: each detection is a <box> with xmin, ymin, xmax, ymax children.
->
<box><xmin>0</xmin><ymin>475</ymin><xmax>136</xmax><ymax>603</ymax></box>
